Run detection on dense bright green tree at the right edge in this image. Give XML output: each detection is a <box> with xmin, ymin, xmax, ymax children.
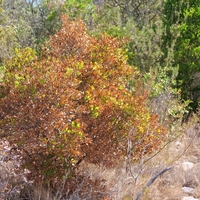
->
<box><xmin>163</xmin><ymin>0</ymin><xmax>200</xmax><ymax>108</ymax></box>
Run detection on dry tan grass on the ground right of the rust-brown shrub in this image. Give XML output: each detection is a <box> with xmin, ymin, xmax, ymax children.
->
<box><xmin>74</xmin><ymin>113</ymin><xmax>200</xmax><ymax>200</ymax></box>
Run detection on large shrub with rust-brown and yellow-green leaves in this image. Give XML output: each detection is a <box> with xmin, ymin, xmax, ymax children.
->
<box><xmin>0</xmin><ymin>16</ymin><xmax>166</xmax><ymax>187</ymax></box>
